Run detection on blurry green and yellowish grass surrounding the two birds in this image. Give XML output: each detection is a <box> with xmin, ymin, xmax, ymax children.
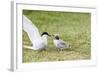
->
<box><xmin>23</xmin><ymin>10</ymin><xmax>91</xmax><ymax>63</ymax></box>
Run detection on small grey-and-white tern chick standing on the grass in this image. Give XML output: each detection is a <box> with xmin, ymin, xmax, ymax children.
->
<box><xmin>53</xmin><ymin>35</ymin><xmax>70</xmax><ymax>51</ymax></box>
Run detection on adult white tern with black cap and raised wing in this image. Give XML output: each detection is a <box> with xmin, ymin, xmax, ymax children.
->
<box><xmin>23</xmin><ymin>15</ymin><xmax>49</xmax><ymax>50</ymax></box>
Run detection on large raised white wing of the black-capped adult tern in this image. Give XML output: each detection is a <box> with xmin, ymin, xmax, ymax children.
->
<box><xmin>23</xmin><ymin>15</ymin><xmax>42</xmax><ymax>50</ymax></box>
